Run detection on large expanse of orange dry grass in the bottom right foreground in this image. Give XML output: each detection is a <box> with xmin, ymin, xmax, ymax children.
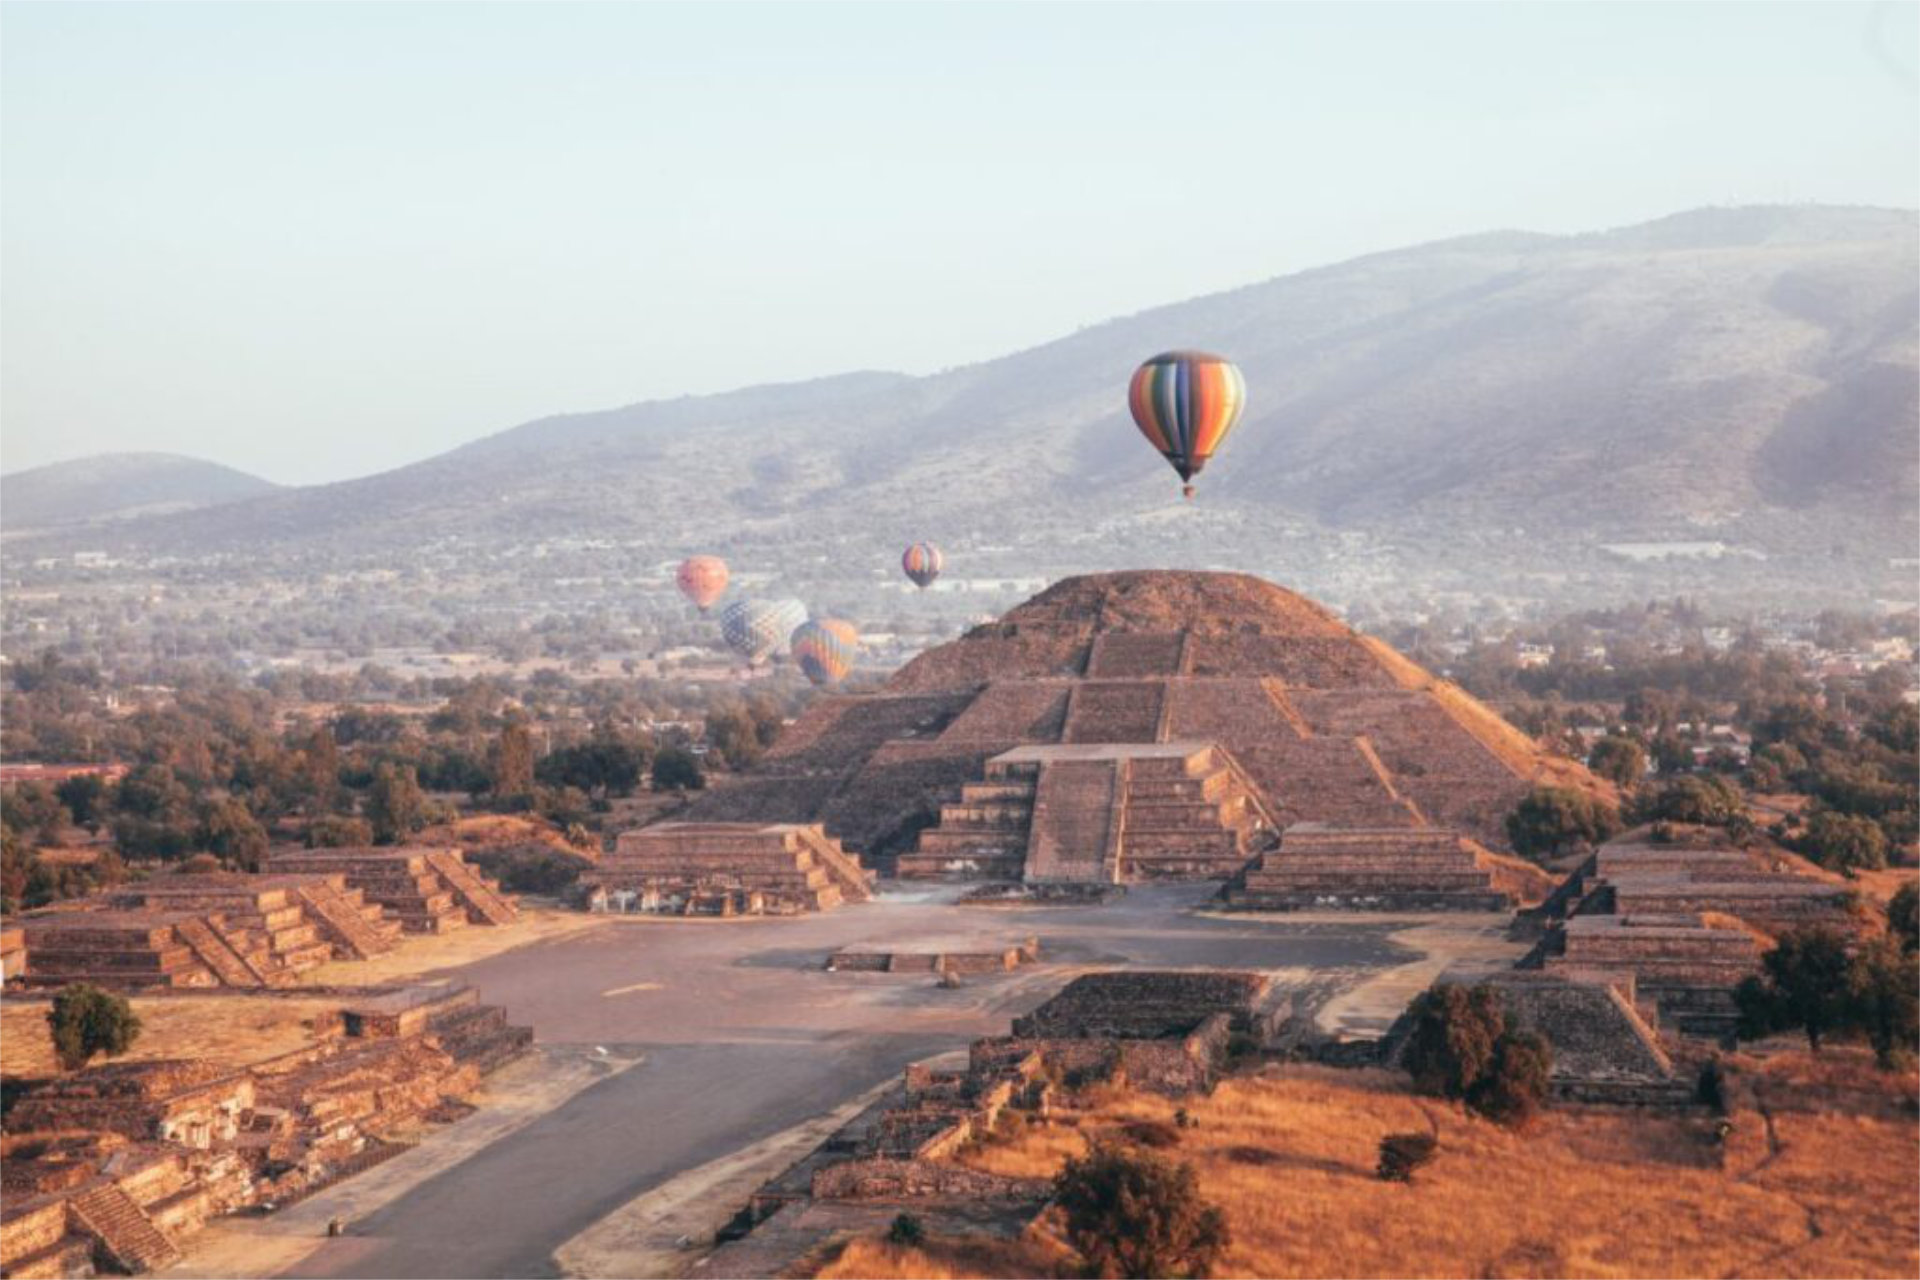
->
<box><xmin>822</xmin><ymin>1052</ymin><xmax>1920</xmax><ymax>1276</ymax></box>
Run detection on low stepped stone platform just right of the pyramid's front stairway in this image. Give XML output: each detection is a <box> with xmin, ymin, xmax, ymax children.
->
<box><xmin>1225</xmin><ymin>823</ymin><xmax>1513</xmax><ymax>912</ymax></box>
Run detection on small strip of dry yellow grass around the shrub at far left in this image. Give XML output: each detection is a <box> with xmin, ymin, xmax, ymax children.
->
<box><xmin>0</xmin><ymin>996</ymin><xmax>340</xmax><ymax>1077</ymax></box>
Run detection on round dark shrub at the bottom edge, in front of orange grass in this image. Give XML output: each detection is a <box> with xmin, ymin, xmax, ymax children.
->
<box><xmin>1054</xmin><ymin>1144</ymin><xmax>1229</xmax><ymax>1280</ymax></box>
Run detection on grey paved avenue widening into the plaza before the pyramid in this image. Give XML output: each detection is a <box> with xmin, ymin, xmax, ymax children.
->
<box><xmin>288</xmin><ymin>887</ymin><xmax>1474</xmax><ymax>1278</ymax></box>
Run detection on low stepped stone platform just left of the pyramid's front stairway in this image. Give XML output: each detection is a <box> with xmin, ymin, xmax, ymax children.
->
<box><xmin>582</xmin><ymin>821</ymin><xmax>874</xmax><ymax>915</ymax></box>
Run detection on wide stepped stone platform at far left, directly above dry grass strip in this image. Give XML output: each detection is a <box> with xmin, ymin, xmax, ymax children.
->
<box><xmin>10</xmin><ymin>873</ymin><xmax>399</xmax><ymax>990</ymax></box>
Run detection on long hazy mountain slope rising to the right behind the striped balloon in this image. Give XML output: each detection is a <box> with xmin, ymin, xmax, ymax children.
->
<box><xmin>18</xmin><ymin>207</ymin><xmax>1920</xmax><ymax>571</ymax></box>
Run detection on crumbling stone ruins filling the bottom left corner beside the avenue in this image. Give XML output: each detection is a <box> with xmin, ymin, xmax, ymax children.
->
<box><xmin>0</xmin><ymin>986</ymin><xmax>532</xmax><ymax>1276</ymax></box>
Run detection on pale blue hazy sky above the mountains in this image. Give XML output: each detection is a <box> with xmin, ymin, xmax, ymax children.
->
<box><xmin>0</xmin><ymin>2</ymin><xmax>1920</xmax><ymax>484</ymax></box>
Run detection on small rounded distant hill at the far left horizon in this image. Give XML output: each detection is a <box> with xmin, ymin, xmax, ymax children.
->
<box><xmin>0</xmin><ymin>453</ymin><xmax>280</xmax><ymax>533</ymax></box>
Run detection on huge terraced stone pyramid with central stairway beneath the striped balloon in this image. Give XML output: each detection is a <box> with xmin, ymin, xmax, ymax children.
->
<box><xmin>687</xmin><ymin>572</ymin><xmax>1613</xmax><ymax>906</ymax></box>
